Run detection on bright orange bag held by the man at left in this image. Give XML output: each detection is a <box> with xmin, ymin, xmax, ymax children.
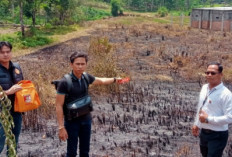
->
<box><xmin>14</xmin><ymin>80</ymin><xmax>41</xmax><ymax>112</ymax></box>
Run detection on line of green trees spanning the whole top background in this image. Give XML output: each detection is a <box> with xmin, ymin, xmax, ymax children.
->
<box><xmin>0</xmin><ymin>0</ymin><xmax>232</xmax><ymax>36</ymax></box>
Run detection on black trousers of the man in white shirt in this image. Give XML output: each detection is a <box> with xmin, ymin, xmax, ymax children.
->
<box><xmin>200</xmin><ymin>129</ymin><xmax>228</xmax><ymax>157</ymax></box>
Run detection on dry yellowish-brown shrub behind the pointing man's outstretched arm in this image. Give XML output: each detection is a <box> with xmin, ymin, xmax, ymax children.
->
<box><xmin>88</xmin><ymin>37</ymin><xmax>123</xmax><ymax>93</ymax></box>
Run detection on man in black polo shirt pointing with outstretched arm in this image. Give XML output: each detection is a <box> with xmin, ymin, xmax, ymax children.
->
<box><xmin>56</xmin><ymin>52</ymin><xmax>121</xmax><ymax>157</ymax></box>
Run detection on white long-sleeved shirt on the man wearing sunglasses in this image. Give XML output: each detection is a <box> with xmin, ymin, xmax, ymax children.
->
<box><xmin>194</xmin><ymin>83</ymin><xmax>232</xmax><ymax>131</ymax></box>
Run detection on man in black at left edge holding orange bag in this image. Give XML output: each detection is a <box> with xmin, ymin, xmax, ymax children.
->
<box><xmin>0</xmin><ymin>41</ymin><xmax>23</xmax><ymax>153</ymax></box>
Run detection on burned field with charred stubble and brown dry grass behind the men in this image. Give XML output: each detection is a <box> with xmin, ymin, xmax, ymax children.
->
<box><xmin>12</xmin><ymin>19</ymin><xmax>232</xmax><ymax>157</ymax></box>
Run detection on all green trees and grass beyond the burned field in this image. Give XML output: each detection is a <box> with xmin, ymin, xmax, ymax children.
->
<box><xmin>0</xmin><ymin>0</ymin><xmax>232</xmax><ymax>49</ymax></box>
